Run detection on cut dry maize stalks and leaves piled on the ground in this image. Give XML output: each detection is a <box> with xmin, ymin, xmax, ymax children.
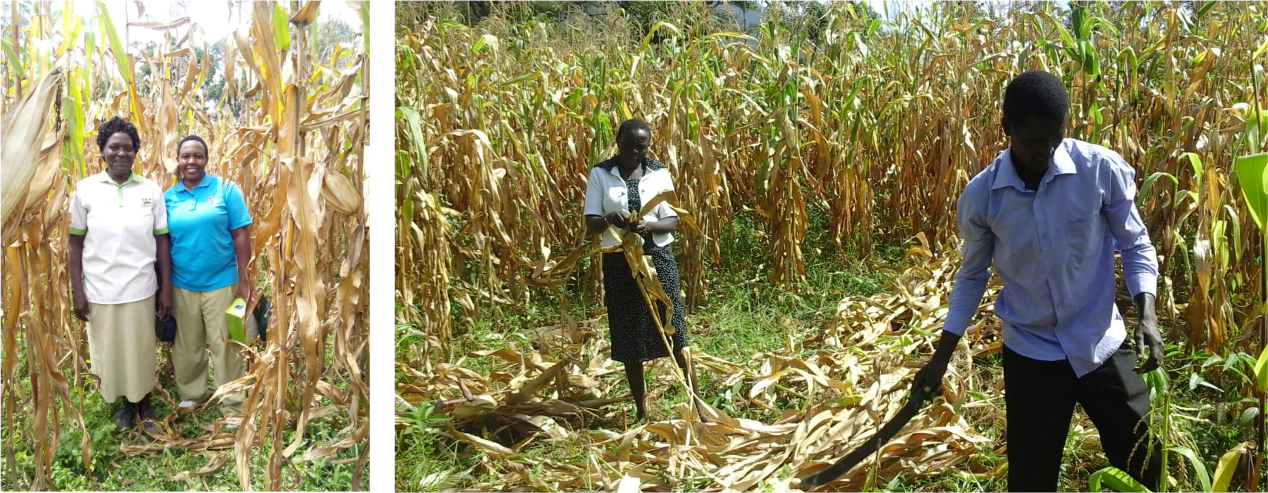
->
<box><xmin>410</xmin><ymin>234</ymin><xmax>1002</xmax><ymax>492</ymax></box>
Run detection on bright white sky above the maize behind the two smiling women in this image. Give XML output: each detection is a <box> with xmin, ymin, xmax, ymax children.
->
<box><xmin>65</xmin><ymin>0</ymin><xmax>361</xmax><ymax>44</ymax></box>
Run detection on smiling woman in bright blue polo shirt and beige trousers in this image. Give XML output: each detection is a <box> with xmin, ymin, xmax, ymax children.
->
<box><xmin>164</xmin><ymin>136</ymin><xmax>251</xmax><ymax>427</ymax></box>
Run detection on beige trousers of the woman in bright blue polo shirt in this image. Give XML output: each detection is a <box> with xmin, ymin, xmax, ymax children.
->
<box><xmin>171</xmin><ymin>284</ymin><xmax>246</xmax><ymax>414</ymax></box>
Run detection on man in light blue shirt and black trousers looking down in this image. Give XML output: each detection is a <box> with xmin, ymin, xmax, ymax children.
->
<box><xmin>913</xmin><ymin>71</ymin><xmax>1163</xmax><ymax>492</ymax></box>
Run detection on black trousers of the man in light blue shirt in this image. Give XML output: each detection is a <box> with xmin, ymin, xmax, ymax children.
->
<box><xmin>1004</xmin><ymin>342</ymin><xmax>1161</xmax><ymax>493</ymax></box>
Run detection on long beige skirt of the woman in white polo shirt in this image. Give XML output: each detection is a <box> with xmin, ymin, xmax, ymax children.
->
<box><xmin>87</xmin><ymin>295</ymin><xmax>159</xmax><ymax>402</ymax></box>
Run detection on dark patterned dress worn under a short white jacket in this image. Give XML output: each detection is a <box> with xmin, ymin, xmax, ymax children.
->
<box><xmin>604</xmin><ymin>161</ymin><xmax>687</xmax><ymax>362</ymax></box>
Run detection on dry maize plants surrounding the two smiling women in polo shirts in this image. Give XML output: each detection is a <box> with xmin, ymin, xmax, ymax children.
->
<box><xmin>0</xmin><ymin>0</ymin><xmax>370</xmax><ymax>490</ymax></box>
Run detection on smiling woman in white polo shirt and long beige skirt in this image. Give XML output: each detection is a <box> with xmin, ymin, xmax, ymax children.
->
<box><xmin>68</xmin><ymin>117</ymin><xmax>172</xmax><ymax>435</ymax></box>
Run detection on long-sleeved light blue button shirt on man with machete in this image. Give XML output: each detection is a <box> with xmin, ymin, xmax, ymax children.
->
<box><xmin>943</xmin><ymin>138</ymin><xmax>1158</xmax><ymax>376</ymax></box>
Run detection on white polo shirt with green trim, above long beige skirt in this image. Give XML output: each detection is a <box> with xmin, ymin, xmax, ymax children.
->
<box><xmin>71</xmin><ymin>171</ymin><xmax>167</xmax><ymax>304</ymax></box>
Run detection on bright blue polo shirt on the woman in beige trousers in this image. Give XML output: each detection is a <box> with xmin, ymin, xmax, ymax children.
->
<box><xmin>162</xmin><ymin>175</ymin><xmax>251</xmax><ymax>291</ymax></box>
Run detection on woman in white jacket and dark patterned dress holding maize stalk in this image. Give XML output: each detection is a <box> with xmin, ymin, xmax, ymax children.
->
<box><xmin>585</xmin><ymin>119</ymin><xmax>708</xmax><ymax>421</ymax></box>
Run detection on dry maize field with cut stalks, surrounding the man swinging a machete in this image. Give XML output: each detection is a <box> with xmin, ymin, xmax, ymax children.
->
<box><xmin>393</xmin><ymin>0</ymin><xmax>1268</xmax><ymax>492</ymax></box>
